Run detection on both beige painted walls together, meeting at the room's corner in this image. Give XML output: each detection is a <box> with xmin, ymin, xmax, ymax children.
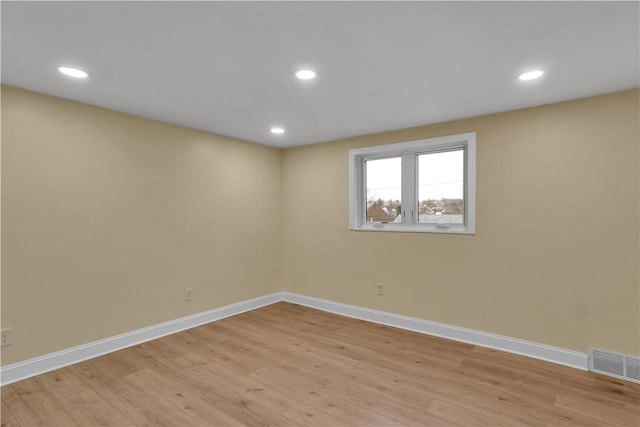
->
<box><xmin>2</xmin><ymin>87</ymin><xmax>640</xmax><ymax>365</ymax></box>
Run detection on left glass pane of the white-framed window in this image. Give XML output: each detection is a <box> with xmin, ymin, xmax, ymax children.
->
<box><xmin>364</xmin><ymin>157</ymin><xmax>402</xmax><ymax>222</ymax></box>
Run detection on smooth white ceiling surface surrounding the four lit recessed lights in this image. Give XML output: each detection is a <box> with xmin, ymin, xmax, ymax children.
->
<box><xmin>1</xmin><ymin>1</ymin><xmax>640</xmax><ymax>147</ymax></box>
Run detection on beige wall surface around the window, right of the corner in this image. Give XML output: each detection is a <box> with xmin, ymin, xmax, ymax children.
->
<box><xmin>282</xmin><ymin>90</ymin><xmax>640</xmax><ymax>355</ymax></box>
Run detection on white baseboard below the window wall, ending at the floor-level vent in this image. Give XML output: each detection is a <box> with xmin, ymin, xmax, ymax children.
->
<box><xmin>282</xmin><ymin>292</ymin><xmax>589</xmax><ymax>371</ymax></box>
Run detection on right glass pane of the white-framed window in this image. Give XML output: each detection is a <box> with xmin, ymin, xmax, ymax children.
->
<box><xmin>418</xmin><ymin>149</ymin><xmax>464</xmax><ymax>224</ymax></box>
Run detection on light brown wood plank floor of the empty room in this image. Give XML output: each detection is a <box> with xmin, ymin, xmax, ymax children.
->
<box><xmin>2</xmin><ymin>303</ymin><xmax>640</xmax><ymax>427</ymax></box>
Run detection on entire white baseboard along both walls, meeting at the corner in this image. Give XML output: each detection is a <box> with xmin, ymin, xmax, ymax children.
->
<box><xmin>0</xmin><ymin>292</ymin><xmax>589</xmax><ymax>385</ymax></box>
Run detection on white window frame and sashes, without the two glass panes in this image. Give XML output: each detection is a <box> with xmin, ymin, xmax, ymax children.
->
<box><xmin>349</xmin><ymin>132</ymin><xmax>476</xmax><ymax>234</ymax></box>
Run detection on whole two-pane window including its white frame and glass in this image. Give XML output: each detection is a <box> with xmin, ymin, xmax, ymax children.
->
<box><xmin>349</xmin><ymin>133</ymin><xmax>476</xmax><ymax>234</ymax></box>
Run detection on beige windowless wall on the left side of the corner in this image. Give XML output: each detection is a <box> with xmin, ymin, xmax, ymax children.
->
<box><xmin>2</xmin><ymin>87</ymin><xmax>282</xmax><ymax>365</ymax></box>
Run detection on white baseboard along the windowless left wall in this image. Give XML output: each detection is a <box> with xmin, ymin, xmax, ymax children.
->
<box><xmin>0</xmin><ymin>292</ymin><xmax>282</xmax><ymax>385</ymax></box>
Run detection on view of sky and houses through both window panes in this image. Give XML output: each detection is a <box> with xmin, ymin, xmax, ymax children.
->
<box><xmin>365</xmin><ymin>149</ymin><xmax>464</xmax><ymax>224</ymax></box>
